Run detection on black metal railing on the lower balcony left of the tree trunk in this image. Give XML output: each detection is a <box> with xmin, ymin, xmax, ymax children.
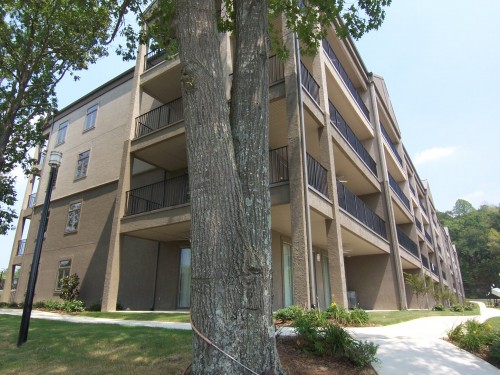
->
<box><xmin>125</xmin><ymin>174</ymin><xmax>189</xmax><ymax>215</ymax></box>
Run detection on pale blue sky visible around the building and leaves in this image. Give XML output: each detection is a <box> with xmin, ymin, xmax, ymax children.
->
<box><xmin>0</xmin><ymin>0</ymin><xmax>500</xmax><ymax>269</ymax></box>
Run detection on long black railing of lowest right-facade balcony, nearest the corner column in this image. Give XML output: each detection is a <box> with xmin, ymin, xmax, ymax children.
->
<box><xmin>337</xmin><ymin>181</ymin><xmax>387</xmax><ymax>239</ymax></box>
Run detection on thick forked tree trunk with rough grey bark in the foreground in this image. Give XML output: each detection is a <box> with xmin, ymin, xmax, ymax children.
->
<box><xmin>176</xmin><ymin>0</ymin><xmax>279</xmax><ymax>374</ymax></box>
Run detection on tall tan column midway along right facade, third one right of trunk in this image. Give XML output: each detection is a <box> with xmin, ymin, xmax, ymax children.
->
<box><xmin>370</xmin><ymin>75</ymin><xmax>408</xmax><ymax>310</ymax></box>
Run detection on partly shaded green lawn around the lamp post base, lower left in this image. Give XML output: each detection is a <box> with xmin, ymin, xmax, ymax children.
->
<box><xmin>0</xmin><ymin>314</ymin><xmax>191</xmax><ymax>375</ymax></box>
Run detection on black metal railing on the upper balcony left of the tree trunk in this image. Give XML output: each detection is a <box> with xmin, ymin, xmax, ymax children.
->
<box><xmin>135</xmin><ymin>98</ymin><xmax>184</xmax><ymax>138</ymax></box>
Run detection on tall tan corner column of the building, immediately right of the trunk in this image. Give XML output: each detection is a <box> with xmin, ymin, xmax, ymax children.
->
<box><xmin>283</xmin><ymin>22</ymin><xmax>311</xmax><ymax>307</ymax></box>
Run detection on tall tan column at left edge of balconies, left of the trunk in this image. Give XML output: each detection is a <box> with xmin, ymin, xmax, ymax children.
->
<box><xmin>101</xmin><ymin>41</ymin><xmax>146</xmax><ymax>311</ymax></box>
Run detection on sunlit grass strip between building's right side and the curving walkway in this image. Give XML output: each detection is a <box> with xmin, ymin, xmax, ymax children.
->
<box><xmin>367</xmin><ymin>304</ymin><xmax>480</xmax><ymax>326</ymax></box>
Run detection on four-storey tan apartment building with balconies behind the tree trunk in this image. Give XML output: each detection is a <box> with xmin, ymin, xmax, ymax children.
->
<box><xmin>2</xmin><ymin>16</ymin><xmax>464</xmax><ymax>311</ymax></box>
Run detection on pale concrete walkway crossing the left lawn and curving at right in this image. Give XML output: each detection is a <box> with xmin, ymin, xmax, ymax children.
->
<box><xmin>0</xmin><ymin>302</ymin><xmax>500</xmax><ymax>375</ymax></box>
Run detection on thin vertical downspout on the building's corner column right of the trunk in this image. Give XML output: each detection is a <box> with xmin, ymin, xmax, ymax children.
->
<box><xmin>294</xmin><ymin>34</ymin><xmax>318</xmax><ymax>309</ymax></box>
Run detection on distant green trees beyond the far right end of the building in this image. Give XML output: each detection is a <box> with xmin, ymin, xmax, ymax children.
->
<box><xmin>438</xmin><ymin>199</ymin><xmax>500</xmax><ymax>298</ymax></box>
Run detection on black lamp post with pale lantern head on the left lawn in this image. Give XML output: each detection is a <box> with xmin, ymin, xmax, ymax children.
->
<box><xmin>17</xmin><ymin>151</ymin><xmax>62</xmax><ymax>347</ymax></box>
